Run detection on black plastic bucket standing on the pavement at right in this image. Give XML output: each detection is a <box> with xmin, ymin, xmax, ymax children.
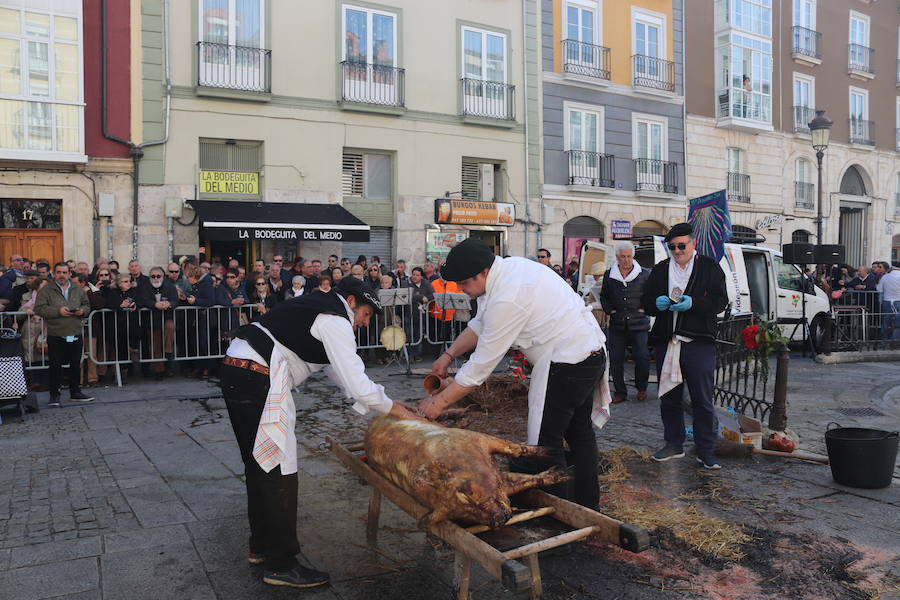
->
<box><xmin>825</xmin><ymin>423</ymin><xmax>900</xmax><ymax>489</ymax></box>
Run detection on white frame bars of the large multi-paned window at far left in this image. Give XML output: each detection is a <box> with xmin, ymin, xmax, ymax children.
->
<box><xmin>0</xmin><ymin>3</ymin><xmax>87</xmax><ymax>163</ymax></box>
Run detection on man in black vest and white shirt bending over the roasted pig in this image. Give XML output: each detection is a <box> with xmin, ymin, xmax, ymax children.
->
<box><xmin>221</xmin><ymin>278</ymin><xmax>416</xmax><ymax>588</ymax></box>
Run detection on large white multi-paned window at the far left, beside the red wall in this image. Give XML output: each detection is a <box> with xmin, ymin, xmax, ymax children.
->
<box><xmin>0</xmin><ymin>4</ymin><xmax>84</xmax><ymax>161</ymax></box>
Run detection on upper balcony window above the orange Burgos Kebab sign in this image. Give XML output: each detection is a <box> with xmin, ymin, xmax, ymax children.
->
<box><xmin>462</xmin><ymin>27</ymin><xmax>513</xmax><ymax>119</ymax></box>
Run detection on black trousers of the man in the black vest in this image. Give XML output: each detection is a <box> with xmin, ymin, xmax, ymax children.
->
<box><xmin>220</xmin><ymin>365</ymin><xmax>300</xmax><ymax>571</ymax></box>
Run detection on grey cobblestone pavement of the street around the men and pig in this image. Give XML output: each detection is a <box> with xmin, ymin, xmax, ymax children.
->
<box><xmin>0</xmin><ymin>357</ymin><xmax>900</xmax><ymax>600</ymax></box>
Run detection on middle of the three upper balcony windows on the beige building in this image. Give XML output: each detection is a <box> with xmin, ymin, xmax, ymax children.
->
<box><xmin>341</xmin><ymin>4</ymin><xmax>402</xmax><ymax>105</ymax></box>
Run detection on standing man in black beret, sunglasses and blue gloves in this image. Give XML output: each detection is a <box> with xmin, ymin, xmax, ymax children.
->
<box><xmin>641</xmin><ymin>223</ymin><xmax>728</xmax><ymax>469</ymax></box>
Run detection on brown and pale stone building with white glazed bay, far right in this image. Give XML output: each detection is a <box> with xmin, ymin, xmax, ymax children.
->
<box><xmin>685</xmin><ymin>0</ymin><xmax>900</xmax><ymax>265</ymax></box>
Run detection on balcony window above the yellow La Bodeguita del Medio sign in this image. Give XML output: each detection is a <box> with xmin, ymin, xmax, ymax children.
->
<box><xmin>198</xmin><ymin>0</ymin><xmax>270</xmax><ymax>92</ymax></box>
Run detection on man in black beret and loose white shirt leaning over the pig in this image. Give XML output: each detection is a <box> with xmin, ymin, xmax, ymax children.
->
<box><xmin>419</xmin><ymin>238</ymin><xmax>610</xmax><ymax>509</ymax></box>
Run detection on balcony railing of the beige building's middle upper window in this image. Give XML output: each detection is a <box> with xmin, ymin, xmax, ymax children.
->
<box><xmin>341</xmin><ymin>60</ymin><xmax>406</xmax><ymax>112</ymax></box>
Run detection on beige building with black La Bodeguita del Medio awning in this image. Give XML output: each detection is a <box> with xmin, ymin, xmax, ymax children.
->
<box><xmin>135</xmin><ymin>0</ymin><xmax>540</xmax><ymax>264</ymax></box>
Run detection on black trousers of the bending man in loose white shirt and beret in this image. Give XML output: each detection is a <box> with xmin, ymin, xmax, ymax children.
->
<box><xmin>510</xmin><ymin>353</ymin><xmax>606</xmax><ymax>508</ymax></box>
